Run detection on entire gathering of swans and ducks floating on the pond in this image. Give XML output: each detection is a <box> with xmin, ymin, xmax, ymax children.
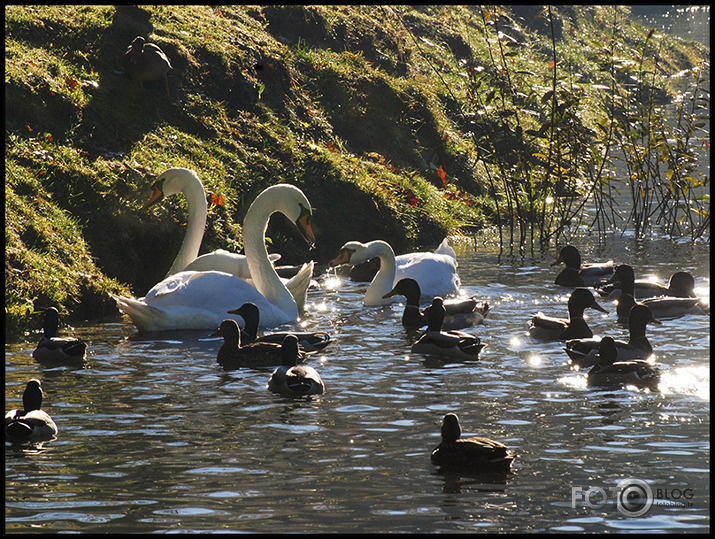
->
<box><xmin>5</xmin><ymin>168</ymin><xmax>709</xmax><ymax>469</ymax></box>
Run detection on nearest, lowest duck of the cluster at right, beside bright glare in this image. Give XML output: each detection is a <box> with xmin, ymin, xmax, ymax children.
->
<box><xmin>587</xmin><ymin>337</ymin><xmax>660</xmax><ymax>390</ymax></box>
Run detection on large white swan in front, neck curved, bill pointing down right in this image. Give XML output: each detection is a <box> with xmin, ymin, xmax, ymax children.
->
<box><xmin>112</xmin><ymin>184</ymin><xmax>315</xmax><ymax>331</ymax></box>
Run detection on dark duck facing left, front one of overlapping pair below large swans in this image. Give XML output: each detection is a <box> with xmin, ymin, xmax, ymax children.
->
<box><xmin>210</xmin><ymin>318</ymin><xmax>307</xmax><ymax>370</ymax></box>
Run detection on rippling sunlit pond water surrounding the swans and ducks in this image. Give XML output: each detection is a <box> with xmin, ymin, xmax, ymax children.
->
<box><xmin>5</xmin><ymin>230</ymin><xmax>710</xmax><ymax>533</ymax></box>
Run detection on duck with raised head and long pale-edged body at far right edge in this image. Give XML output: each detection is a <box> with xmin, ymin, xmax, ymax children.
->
<box><xmin>609</xmin><ymin>264</ymin><xmax>710</xmax><ymax>320</ymax></box>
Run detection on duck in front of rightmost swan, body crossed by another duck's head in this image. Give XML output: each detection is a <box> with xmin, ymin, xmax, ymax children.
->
<box><xmin>383</xmin><ymin>277</ymin><xmax>490</xmax><ymax>330</ymax></box>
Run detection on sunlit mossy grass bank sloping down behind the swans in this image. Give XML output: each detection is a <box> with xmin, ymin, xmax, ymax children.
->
<box><xmin>5</xmin><ymin>6</ymin><xmax>708</xmax><ymax>338</ymax></box>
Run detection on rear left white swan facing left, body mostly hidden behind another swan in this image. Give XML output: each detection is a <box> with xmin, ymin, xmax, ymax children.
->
<box><xmin>142</xmin><ymin>167</ymin><xmax>281</xmax><ymax>280</ymax></box>
